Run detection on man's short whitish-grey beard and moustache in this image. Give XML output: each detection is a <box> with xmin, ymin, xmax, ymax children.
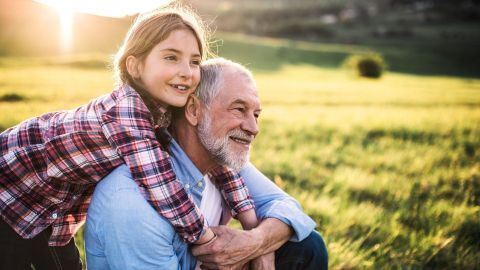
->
<box><xmin>198</xmin><ymin>113</ymin><xmax>252</xmax><ymax>171</ymax></box>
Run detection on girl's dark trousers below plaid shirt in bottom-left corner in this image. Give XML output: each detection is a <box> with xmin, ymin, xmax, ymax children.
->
<box><xmin>0</xmin><ymin>218</ymin><xmax>82</xmax><ymax>270</ymax></box>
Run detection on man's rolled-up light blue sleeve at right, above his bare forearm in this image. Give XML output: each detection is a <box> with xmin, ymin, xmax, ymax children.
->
<box><xmin>240</xmin><ymin>164</ymin><xmax>316</xmax><ymax>242</ymax></box>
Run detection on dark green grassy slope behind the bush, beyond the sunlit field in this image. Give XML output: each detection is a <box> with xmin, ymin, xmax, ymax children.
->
<box><xmin>214</xmin><ymin>31</ymin><xmax>480</xmax><ymax>78</ymax></box>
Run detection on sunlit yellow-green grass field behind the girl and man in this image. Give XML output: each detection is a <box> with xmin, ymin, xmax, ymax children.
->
<box><xmin>0</xmin><ymin>39</ymin><xmax>480</xmax><ymax>269</ymax></box>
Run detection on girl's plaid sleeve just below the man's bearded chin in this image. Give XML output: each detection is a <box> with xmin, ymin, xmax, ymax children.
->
<box><xmin>208</xmin><ymin>166</ymin><xmax>255</xmax><ymax>217</ymax></box>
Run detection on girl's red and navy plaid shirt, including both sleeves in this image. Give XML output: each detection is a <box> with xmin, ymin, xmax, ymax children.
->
<box><xmin>0</xmin><ymin>85</ymin><xmax>253</xmax><ymax>246</ymax></box>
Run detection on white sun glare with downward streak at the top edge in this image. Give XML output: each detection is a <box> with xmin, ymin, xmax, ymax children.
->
<box><xmin>34</xmin><ymin>0</ymin><xmax>173</xmax><ymax>53</ymax></box>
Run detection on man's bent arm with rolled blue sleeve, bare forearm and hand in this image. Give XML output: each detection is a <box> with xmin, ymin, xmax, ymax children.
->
<box><xmin>192</xmin><ymin>164</ymin><xmax>316</xmax><ymax>268</ymax></box>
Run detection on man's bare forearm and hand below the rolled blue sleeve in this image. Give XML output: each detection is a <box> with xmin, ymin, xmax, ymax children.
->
<box><xmin>192</xmin><ymin>218</ymin><xmax>293</xmax><ymax>269</ymax></box>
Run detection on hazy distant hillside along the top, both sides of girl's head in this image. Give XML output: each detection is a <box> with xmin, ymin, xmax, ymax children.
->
<box><xmin>0</xmin><ymin>0</ymin><xmax>480</xmax><ymax>55</ymax></box>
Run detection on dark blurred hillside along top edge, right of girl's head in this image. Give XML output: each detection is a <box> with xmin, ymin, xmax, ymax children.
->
<box><xmin>189</xmin><ymin>0</ymin><xmax>480</xmax><ymax>43</ymax></box>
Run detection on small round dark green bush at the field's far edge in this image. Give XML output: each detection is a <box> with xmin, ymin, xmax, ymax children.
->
<box><xmin>344</xmin><ymin>53</ymin><xmax>387</xmax><ymax>79</ymax></box>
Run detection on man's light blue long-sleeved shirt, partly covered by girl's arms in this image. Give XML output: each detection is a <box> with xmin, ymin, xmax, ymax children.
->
<box><xmin>85</xmin><ymin>141</ymin><xmax>315</xmax><ymax>270</ymax></box>
